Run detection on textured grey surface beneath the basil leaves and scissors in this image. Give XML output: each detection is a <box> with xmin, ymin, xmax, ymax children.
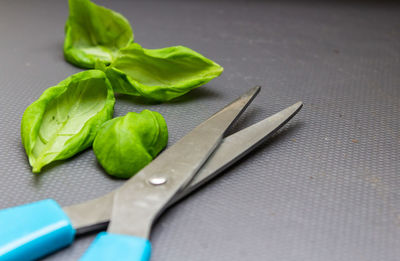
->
<box><xmin>0</xmin><ymin>0</ymin><xmax>400</xmax><ymax>261</ymax></box>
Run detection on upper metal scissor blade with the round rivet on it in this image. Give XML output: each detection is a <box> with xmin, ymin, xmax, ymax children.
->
<box><xmin>107</xmin><ymin>87</ymin><xmax>260</xmax><ymax>238</ymax></box>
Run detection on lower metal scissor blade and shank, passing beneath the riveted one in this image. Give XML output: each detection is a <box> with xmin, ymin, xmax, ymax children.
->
<box><xmin>64</xmin><ymin>99</ymin><xmax>303</xmax><ymax>235</ymax></box>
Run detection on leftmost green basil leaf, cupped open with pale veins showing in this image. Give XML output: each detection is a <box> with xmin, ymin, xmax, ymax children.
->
<box><xmin>21</xmin><ymin>70</ymin><xmax>115</xmax><ymax>172</ymax></box>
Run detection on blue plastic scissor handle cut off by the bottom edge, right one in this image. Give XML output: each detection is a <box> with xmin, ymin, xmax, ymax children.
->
<box><xmin>80</xmin><ymin>232</ymin><xmax>151</xmax><ymax>261</ymax></box>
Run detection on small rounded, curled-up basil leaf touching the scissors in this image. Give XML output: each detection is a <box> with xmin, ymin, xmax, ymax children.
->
<box><xmin>93</xmin><ymin>110</ymin><xmax>168</xmax><ymax>178</ymax></box>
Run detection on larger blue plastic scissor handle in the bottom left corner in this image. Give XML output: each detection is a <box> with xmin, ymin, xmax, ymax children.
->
<box><xmin>0</xmin><ymin>199</ymin><xmax>75</xmax><ymax>261</ymax></box>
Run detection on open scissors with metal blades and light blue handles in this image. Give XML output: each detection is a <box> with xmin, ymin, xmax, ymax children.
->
<box><xmin>0</xmin><ymin>86</ymin><xmax>303</xmax><ymax>261</ymax></box>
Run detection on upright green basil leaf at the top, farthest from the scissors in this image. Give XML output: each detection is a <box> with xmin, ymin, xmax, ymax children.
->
<box><xmin>64</xmin><ymin>0</ymin><xmax>133</xmax><ymax>68</ymax></box>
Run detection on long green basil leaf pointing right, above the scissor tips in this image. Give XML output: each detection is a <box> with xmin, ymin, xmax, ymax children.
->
<box><xmin>105</xmin><ymin>43</ymin><xmax>223</xmax><ymax>101</ymax></box>
